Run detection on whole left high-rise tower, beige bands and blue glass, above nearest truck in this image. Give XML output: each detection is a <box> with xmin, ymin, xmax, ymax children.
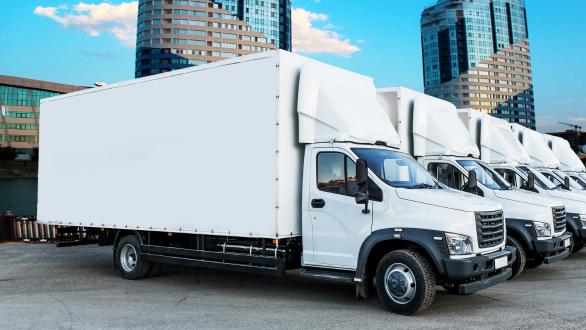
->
<box><xmin>135</xmin><ymin>0</ymin><xmax>291</xmax><ymax>78</ymax></box>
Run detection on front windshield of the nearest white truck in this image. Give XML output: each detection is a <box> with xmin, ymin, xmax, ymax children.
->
<box><xmin>352</xmin><ymin>148</ymin><xmax>439</xmax><ymax>189</ymax></box>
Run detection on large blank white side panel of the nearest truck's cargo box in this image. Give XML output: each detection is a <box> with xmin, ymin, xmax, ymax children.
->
<box><xmin>38</xmin><ymin>52</ymin><xmax>300</xmax><ymax>237</ymax></box>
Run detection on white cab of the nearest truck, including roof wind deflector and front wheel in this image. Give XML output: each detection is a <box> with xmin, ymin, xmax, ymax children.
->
<box><xmin>297</xmin><ymin>66</ymin><xmax>515</xmax><ymax>314</ymax></box>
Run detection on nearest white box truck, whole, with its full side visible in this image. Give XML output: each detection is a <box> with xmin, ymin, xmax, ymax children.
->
<box><xmin>38</xmin><ymin>51</ymin><xmax>514</xmax><ymax>315</ymax></box>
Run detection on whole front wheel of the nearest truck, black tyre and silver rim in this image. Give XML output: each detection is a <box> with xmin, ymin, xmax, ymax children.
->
<box><xmin>376</xmin><ymin>250</ymin><xmax>435</xmax><ymax>315</ymax></box>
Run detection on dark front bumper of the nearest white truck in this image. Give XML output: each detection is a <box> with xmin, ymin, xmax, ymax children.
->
<box><xmin>444</xmin><ymin>246</ymin><xmax>516</xmax><ymax>294</ymax></box>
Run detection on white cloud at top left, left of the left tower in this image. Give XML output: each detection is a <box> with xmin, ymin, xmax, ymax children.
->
<box><xmin>34</xmin><ymin>1</ymin><xmax>138</xmax><ymax>47</ymax></box>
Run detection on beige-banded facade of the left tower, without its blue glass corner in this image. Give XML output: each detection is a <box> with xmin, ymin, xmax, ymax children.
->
<box><xmin>135</xmin><ymin>0</ymin><xmax>277</xmax><ymax>78</ymax></box>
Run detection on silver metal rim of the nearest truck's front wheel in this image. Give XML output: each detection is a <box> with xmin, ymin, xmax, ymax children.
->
<box><xmin>384</xmin><ymin>263</ymin><xmax>417</xmax><ymax>304</ymax></box>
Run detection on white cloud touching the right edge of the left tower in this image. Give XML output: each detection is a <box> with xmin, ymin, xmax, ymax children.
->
<box><xmin>291</xmin><ymin>8</ymin><xmax>360</xmax><ymax>56</ymax></box>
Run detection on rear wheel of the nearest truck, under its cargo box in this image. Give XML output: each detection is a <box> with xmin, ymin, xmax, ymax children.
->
<box><xmin>116</xmin><ymin>235</ymin><xmax>151</xmax><ymax>280</ymax></box>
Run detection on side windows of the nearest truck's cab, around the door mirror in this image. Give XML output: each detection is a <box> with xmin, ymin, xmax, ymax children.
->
<box><xmin>317</xmin><ymin>152</ymin><xmax>383</xmax><ymax>202</ymax></box>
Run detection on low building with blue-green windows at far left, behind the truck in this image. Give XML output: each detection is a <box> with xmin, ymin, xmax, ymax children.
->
<box><xmin>0</xmin><ymin>76</ymin><xmax>87</xmax><ymax>160</ymax></box>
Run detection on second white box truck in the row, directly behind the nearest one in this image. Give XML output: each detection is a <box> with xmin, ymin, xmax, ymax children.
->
<box><xmin>378</xmin><ymin>87</ymin><xmax>571</xmax><ymax>277</ymax></box>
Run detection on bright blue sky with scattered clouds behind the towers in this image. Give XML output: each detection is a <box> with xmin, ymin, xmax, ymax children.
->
<box><xmin>0</xmin><ymin>0</ymin><xmax>586</xmax><ymax>132</ymax></box>
